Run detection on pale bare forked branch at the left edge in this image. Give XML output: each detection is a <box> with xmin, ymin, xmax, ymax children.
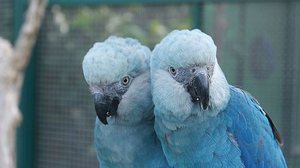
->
<box><xmin>0</xmin><ymin>0</ymin><xmax>47</xmax><ymax>168</ymax></box>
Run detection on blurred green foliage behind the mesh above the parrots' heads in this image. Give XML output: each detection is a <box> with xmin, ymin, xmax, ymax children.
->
<box><xmin>52</xmin><ymin>5</ymin><xmax>191</xmax><ymax>47</ymax></box>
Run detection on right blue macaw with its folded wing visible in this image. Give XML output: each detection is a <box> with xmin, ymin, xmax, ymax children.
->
<box><xmin>150</xmin><ymin>29</ymin><xmax>287</xmax><ymax>168</ymax></box>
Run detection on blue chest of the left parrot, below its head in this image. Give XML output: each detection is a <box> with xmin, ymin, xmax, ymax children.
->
<box><xmin>95</xmin><ymin>122</ymin><xmax>164</xmax><ymax>167</ymax></box>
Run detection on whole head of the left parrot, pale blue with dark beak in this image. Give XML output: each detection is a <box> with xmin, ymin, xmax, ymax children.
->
<box><xmin>82</xmin><ymin>36</ymin><xmax>153</xmax><ymax>124</ymax></box>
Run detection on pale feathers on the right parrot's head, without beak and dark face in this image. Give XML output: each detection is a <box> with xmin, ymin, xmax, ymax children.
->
<box><xmin>151</xmin><ymin>29</ymin><xmax>230</xmax><ymax>122</ymax></box>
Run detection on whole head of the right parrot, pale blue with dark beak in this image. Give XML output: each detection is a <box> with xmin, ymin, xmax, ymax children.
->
<box><xmin>151</xmin><ymin>29</ymin><xmax>229</xmax><ymax>121</ymax></box>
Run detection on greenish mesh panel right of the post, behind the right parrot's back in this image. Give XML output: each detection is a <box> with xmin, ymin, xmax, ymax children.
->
<box><xmin>203</xmin><ymin>2</ymin><xmax>300</xmax><ymax>167</ymax></box>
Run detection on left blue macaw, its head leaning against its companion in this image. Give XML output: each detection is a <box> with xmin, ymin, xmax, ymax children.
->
<box><xmin>82</xmin><ymin>36</ymin><xmax>168</xmax><ymax>168</ymax></box>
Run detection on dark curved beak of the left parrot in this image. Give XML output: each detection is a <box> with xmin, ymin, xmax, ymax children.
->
<box><xmin>94</xmin><ymin>93</ymin><xmax>120</xmax><ymax>125</ymax></box>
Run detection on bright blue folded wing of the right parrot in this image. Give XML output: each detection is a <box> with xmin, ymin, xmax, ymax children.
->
<box><xmin>224</xmin><ymin>87</ymin><xmax>287</xmax><ymax>167</ymax></box>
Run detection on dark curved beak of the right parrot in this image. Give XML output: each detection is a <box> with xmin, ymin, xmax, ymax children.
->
<box><xmin>186</xmin><ymin>73</ymin><xmax>209</xmax><ymax>110</ymax></box>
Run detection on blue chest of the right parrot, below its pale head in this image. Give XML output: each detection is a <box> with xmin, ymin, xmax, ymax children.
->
<box><xmin>160</xmin><ymin>115</ymin><xmax>242</xmax><ymax>167</ymax></box>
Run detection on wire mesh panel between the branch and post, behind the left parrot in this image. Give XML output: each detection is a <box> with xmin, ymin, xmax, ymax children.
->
<box><xmin>35</xmin><ymin>5</ymin><xmax>191</xmax><ymax>168</ymax></box>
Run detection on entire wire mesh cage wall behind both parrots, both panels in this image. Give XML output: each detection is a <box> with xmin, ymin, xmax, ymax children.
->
<box><xmin>0</xmin><ymin>0</ymin><xmax>300</xmax><ymax>168</ymax></box>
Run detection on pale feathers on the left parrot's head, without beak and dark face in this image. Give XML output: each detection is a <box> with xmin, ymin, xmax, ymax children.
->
<box><xmin>82</xmin><ymin>36</ymin><xmax>153</xmax><ymax>124</ymax></box>
